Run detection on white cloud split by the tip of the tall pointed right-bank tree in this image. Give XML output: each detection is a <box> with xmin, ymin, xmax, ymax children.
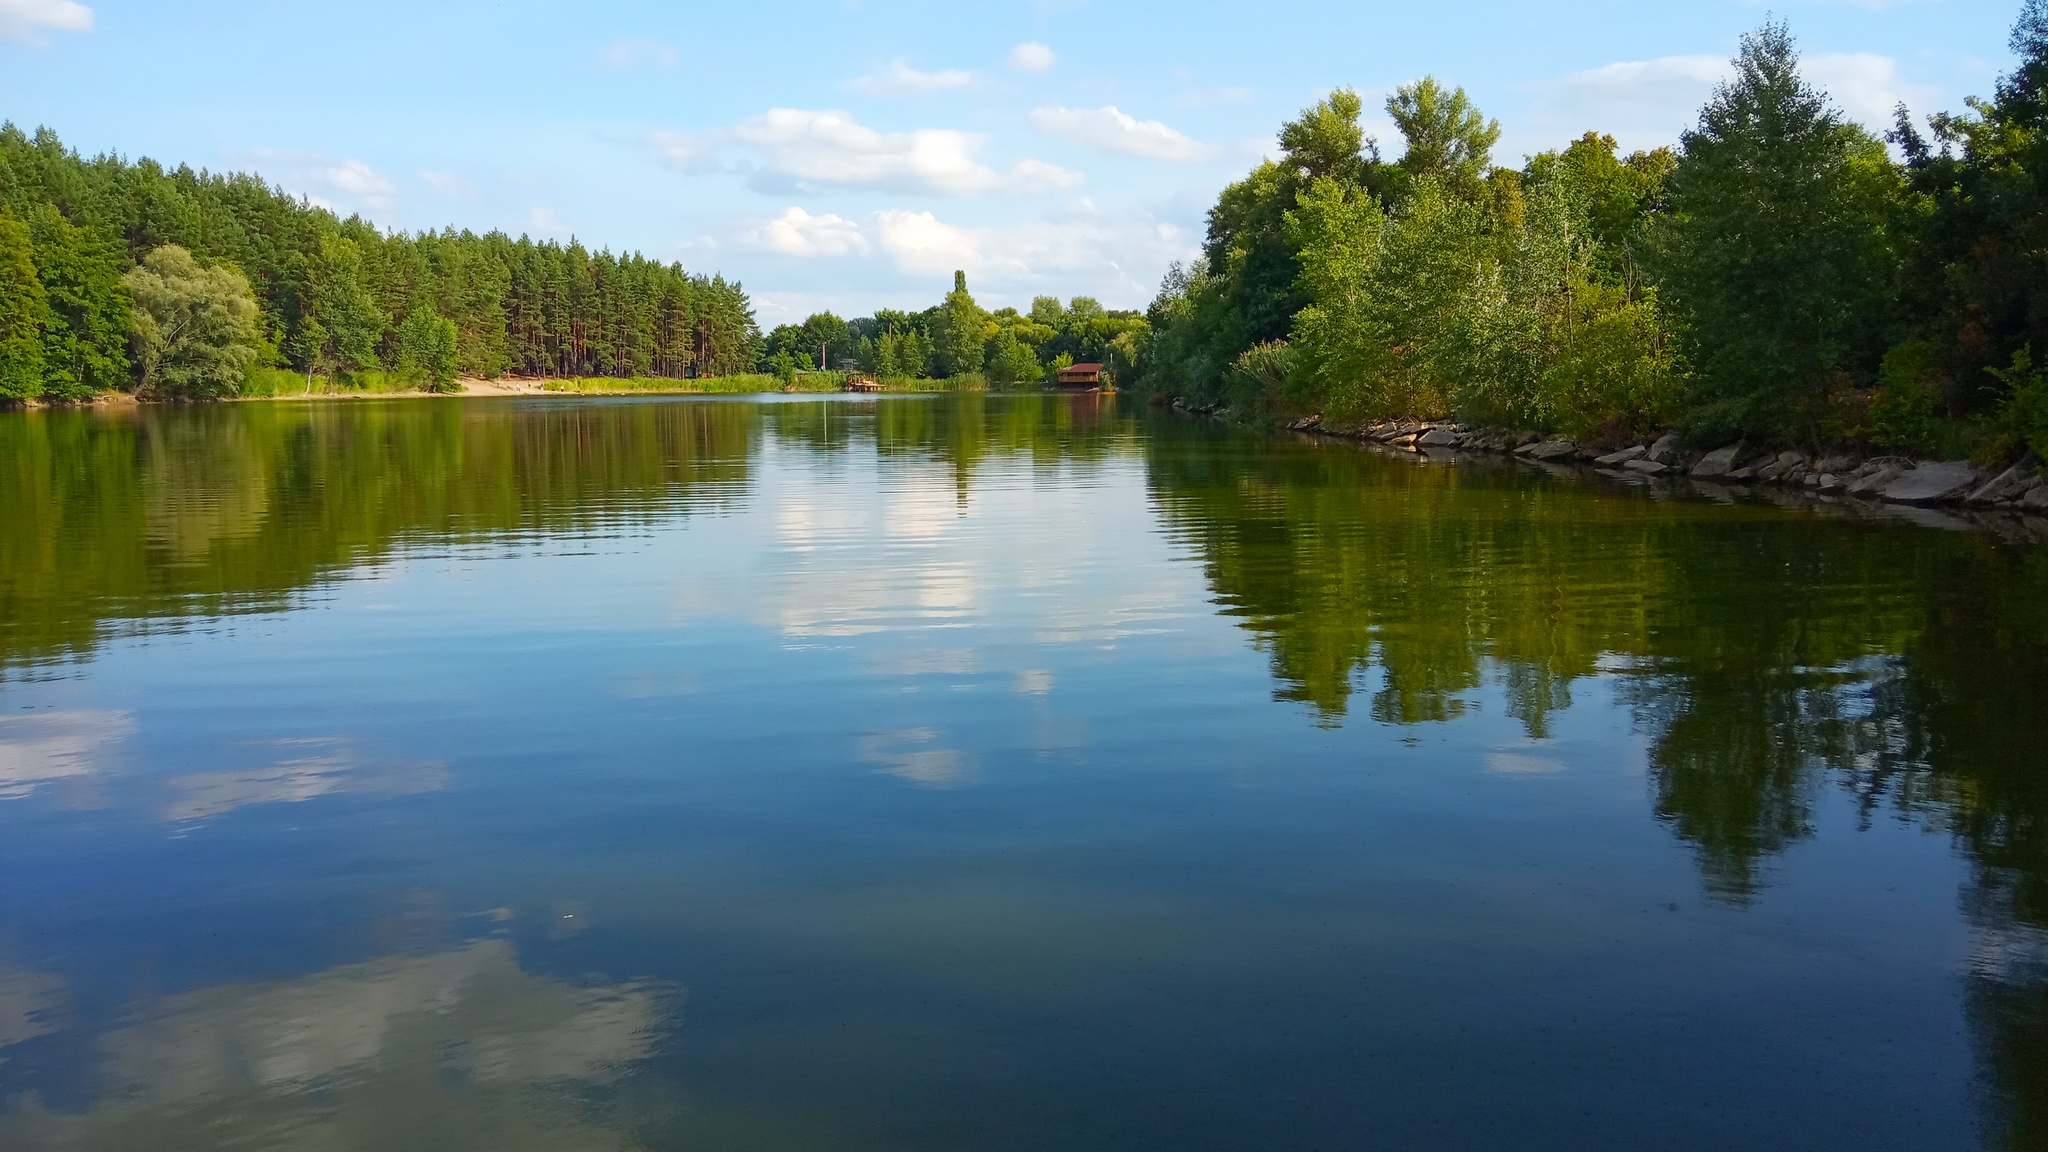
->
<box><xmin>1534</xmin><ymin>53</ymin><xmax>1933</xmax><ymax>148</ymax></box>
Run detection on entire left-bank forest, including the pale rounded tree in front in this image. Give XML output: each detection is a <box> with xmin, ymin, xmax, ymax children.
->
<box><xmin>0</xmin><ymin>125</ymin><xmax>760</xmax><ymax>400</ymax></box>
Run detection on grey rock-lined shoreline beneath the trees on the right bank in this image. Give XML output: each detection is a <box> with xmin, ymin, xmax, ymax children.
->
<box><xmin>1174</xmin><ymin>404</ymin><xmax>2048</xmax><ymax>543</ymax></box>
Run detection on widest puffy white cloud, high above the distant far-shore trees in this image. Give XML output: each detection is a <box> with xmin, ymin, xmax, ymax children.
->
<box><xmin>653</xmin><ymin>109</ymin><xmax>1081</xmax><ymax>195</ymax></box>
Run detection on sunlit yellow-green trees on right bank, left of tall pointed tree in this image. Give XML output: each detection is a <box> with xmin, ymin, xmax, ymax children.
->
<box><xmin>1286</xmin><ymin>174</ymin><xmax>1679</xmax><ymax>437</ymax></box>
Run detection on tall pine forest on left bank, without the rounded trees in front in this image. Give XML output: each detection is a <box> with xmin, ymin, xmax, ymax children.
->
<box><xmin>0</xmin><ymin>125</ymin><xmax>760</xmax><ymax>396</ymax></box>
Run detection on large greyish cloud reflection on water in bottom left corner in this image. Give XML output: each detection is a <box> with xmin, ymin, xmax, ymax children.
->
<box><xmin>0</xmin><ymin>939</ymin><xmax>670</xmax><ymax>1152</ymax></box>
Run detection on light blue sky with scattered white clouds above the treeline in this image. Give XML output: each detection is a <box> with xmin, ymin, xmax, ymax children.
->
<box><xmin>0</xmin><ymin>0</ymin><xmax>2019</xmax><ymax>324</ymax></box>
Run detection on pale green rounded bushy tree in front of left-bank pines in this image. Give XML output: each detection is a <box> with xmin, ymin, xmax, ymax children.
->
<box><xmin>123</xmin><ymin>244</ymin><xmax>266</xmax><ymax>398</ymax></box>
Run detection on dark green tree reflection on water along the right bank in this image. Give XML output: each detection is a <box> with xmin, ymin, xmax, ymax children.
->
<box><xmin>1149</xmin><ymin>424</ymin><xmax>2048</xmax><ymax>1148</ymax></box>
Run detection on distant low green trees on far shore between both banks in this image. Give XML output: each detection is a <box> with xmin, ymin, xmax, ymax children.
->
<box><xmin>762</xmin><ymin>273</ymin><xmax>1151</xmax><ymax>387</ymax></box>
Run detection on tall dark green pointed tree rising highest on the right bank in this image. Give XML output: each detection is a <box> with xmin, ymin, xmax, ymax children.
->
<box><xmin>1659</xmin><ymin>25</ymin><xmax>1898</xmax><ymax>441</ymax></box>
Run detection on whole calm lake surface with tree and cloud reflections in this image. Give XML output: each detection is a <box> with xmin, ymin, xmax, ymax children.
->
<box><xmin>0</xmin><ymin>396</ymin><xmax>2048</xmax><ymax>1152</ymax></box>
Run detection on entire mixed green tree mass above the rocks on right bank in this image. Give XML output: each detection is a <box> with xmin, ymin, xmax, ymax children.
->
<box><xmin>1133</xmin><ymin>0</ymin><xmax>2048</xmax><ymax>457</ymax></box>
